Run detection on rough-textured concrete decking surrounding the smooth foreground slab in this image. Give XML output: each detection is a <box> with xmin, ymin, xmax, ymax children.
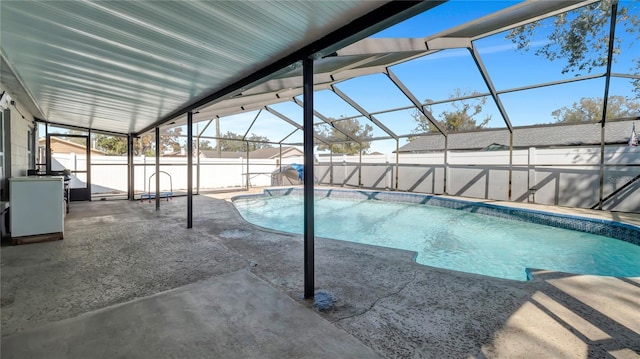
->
<box><xmin>0</xmin><ymin>196</ymin><xmax>640</xmax><ymax>358</ymax></box>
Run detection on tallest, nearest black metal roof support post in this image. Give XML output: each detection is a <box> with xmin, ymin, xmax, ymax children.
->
<box><xmin>302</xmin><ymin>57</ymin><xmax>315</xmax><ymax>299</ymax></box>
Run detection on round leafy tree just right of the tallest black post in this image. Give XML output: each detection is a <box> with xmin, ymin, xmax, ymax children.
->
<box><xmin>318</xmin><ymin>118</ymin><xmax>373</xmax><ymax>155</ymax></box>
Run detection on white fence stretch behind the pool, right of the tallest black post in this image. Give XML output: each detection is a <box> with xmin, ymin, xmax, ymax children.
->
<box><xmin>321</xmin><ymin>146</ymin><xmax>640</xmax><ymax>212</ymax></box>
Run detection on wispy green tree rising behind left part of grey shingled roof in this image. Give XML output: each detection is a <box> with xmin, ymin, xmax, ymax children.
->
<box><xmin>410</xmin><ymin>89</ymin><xmax>491</xmax><ymax>135</ymax></box>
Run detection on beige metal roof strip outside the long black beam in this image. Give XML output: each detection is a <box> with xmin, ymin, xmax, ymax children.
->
<box><xmin>188</xmin><ymin>0</ymin><xmax>597</xmax><ymax>133</ymax></box>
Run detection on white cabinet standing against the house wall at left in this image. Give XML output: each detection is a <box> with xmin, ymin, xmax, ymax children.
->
<box><xmin>9</xmin><ymin>177</ymin><xmax>64</xmax><ymax>243</ymax></box>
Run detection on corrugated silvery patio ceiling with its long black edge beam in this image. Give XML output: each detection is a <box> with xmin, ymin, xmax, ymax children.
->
<box><xmin>0</xmin><ymin>0</ymin><xmax>440</xmax><ymax>133</ymax></box>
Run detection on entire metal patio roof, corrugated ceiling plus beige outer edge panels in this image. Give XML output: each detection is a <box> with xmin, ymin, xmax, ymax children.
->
<box><xmin>0</xmin><ymin>0</ymin><xmax>594</xmax><ymax>138</ymax></box>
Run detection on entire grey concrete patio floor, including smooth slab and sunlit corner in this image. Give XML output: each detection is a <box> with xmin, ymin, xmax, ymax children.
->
<box><xmin>0</xmin><ymin>195</ymin><xmax>640</xmax><ymax>358</ymax></box>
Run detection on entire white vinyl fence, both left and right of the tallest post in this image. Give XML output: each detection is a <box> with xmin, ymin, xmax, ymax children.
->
<box><xmin>54</xmin><ymin>147</ymin><xmax>640</xmax><ymax>213</ymax></box>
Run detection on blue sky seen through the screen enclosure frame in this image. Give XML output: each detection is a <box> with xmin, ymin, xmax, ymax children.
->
<box><xmin>195</xmin><ymin>0</ymin><xmax>640</xmax><ymax>153</ymax></box>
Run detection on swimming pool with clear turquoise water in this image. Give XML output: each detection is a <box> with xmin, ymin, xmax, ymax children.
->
<box><xmin>233</xmin><ymin>189</ymin><xmax>640</xmax><ymax>280</ymax></box>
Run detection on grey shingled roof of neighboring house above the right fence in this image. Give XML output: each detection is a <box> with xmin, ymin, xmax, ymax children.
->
<box><xmin>398</xmin><ymin>119</ymin><xmax>637</xmax><ymax>153</ymax></box>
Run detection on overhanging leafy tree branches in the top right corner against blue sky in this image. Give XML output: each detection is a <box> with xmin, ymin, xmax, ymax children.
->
<box><xmin>506</xmin><ymin>0</ymin><xmax>640</xmax><ymax>97</ymax></box>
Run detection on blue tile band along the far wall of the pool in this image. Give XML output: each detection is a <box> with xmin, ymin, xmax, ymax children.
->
<box><xmin>249</xmin><ymin>187</ymin><xmax>640</xmax><ymax>246</ymax></box>
